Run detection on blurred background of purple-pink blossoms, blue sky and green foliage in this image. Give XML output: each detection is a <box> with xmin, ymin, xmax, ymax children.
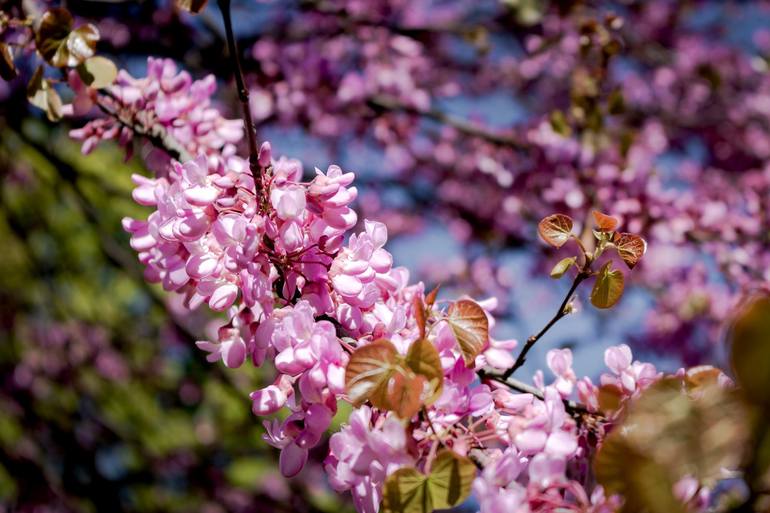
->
<box><xmin>0</xmin><ymin>0</ymin><xmax>770</xmax><ymax>513</ymax></box>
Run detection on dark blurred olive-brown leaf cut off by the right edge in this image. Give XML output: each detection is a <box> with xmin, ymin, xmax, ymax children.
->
<box><xmin>730</xmin><ymin>297</ymin><xmax>770</xmax><ymax>408</ymax></box>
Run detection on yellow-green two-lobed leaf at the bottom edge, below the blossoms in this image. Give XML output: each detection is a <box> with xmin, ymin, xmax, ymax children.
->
<box><xmin>382</xmin><ymin>450</ymin><xmax>476</xmax><ymax>513</ymax></box>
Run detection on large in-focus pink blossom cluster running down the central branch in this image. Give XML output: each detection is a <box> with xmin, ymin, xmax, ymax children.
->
<box><xmin>124</xmin><ymin>125</ymin><xmax>704</xmax><ymax>513</ymax></box>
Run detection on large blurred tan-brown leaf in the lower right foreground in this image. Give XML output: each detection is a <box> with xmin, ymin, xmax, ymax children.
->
<box><xmin>596</xmin><ymin>371</ymin><xmax>750</xmax><ymax>500</ymax></box>
